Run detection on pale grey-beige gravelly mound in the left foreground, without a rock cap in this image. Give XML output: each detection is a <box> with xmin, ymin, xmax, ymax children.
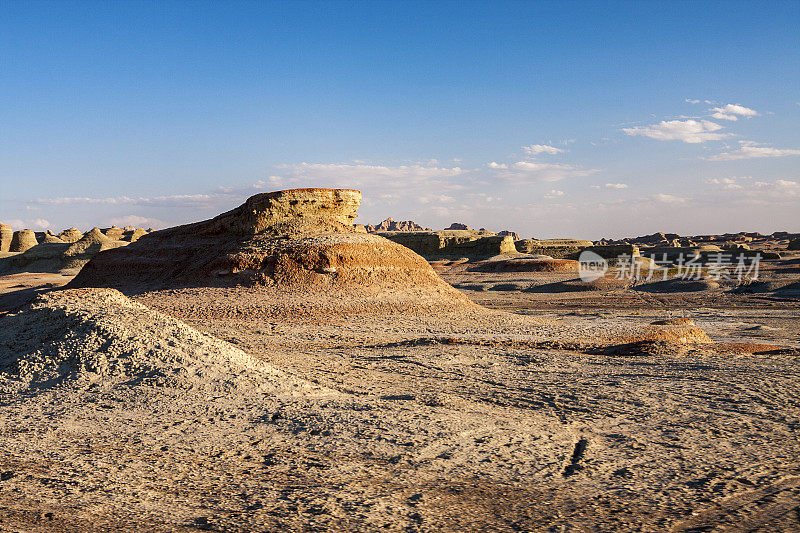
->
<box><xmin>0</xmin><ymin>289</ymin><xmax>286</xmax><ymax>389</ymax></box>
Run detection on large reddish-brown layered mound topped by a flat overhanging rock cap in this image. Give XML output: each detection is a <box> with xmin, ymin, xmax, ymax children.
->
<box><xmin>70</xmin><ymin>189</ymin><xmax>472</xmax><ymax>312</ymax></box>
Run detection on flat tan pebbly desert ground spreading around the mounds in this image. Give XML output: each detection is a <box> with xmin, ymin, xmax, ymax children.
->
<box><xmin>0</xmin><ymin>260</ymin><xmax>800</xmax><ymax>531</ymax></box>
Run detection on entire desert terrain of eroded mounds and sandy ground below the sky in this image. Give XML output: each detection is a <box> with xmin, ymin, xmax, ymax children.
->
<box><xmin>0</xmin><ymin>189</ymin><xmax>800</xmax><ymax>532</ymax></box>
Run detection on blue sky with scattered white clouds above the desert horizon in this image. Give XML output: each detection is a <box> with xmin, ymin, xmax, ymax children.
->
<box><xmin>0</xmin><ymin>0</ymin><xmax>800</xmax><ymax>239</ymax></box>
